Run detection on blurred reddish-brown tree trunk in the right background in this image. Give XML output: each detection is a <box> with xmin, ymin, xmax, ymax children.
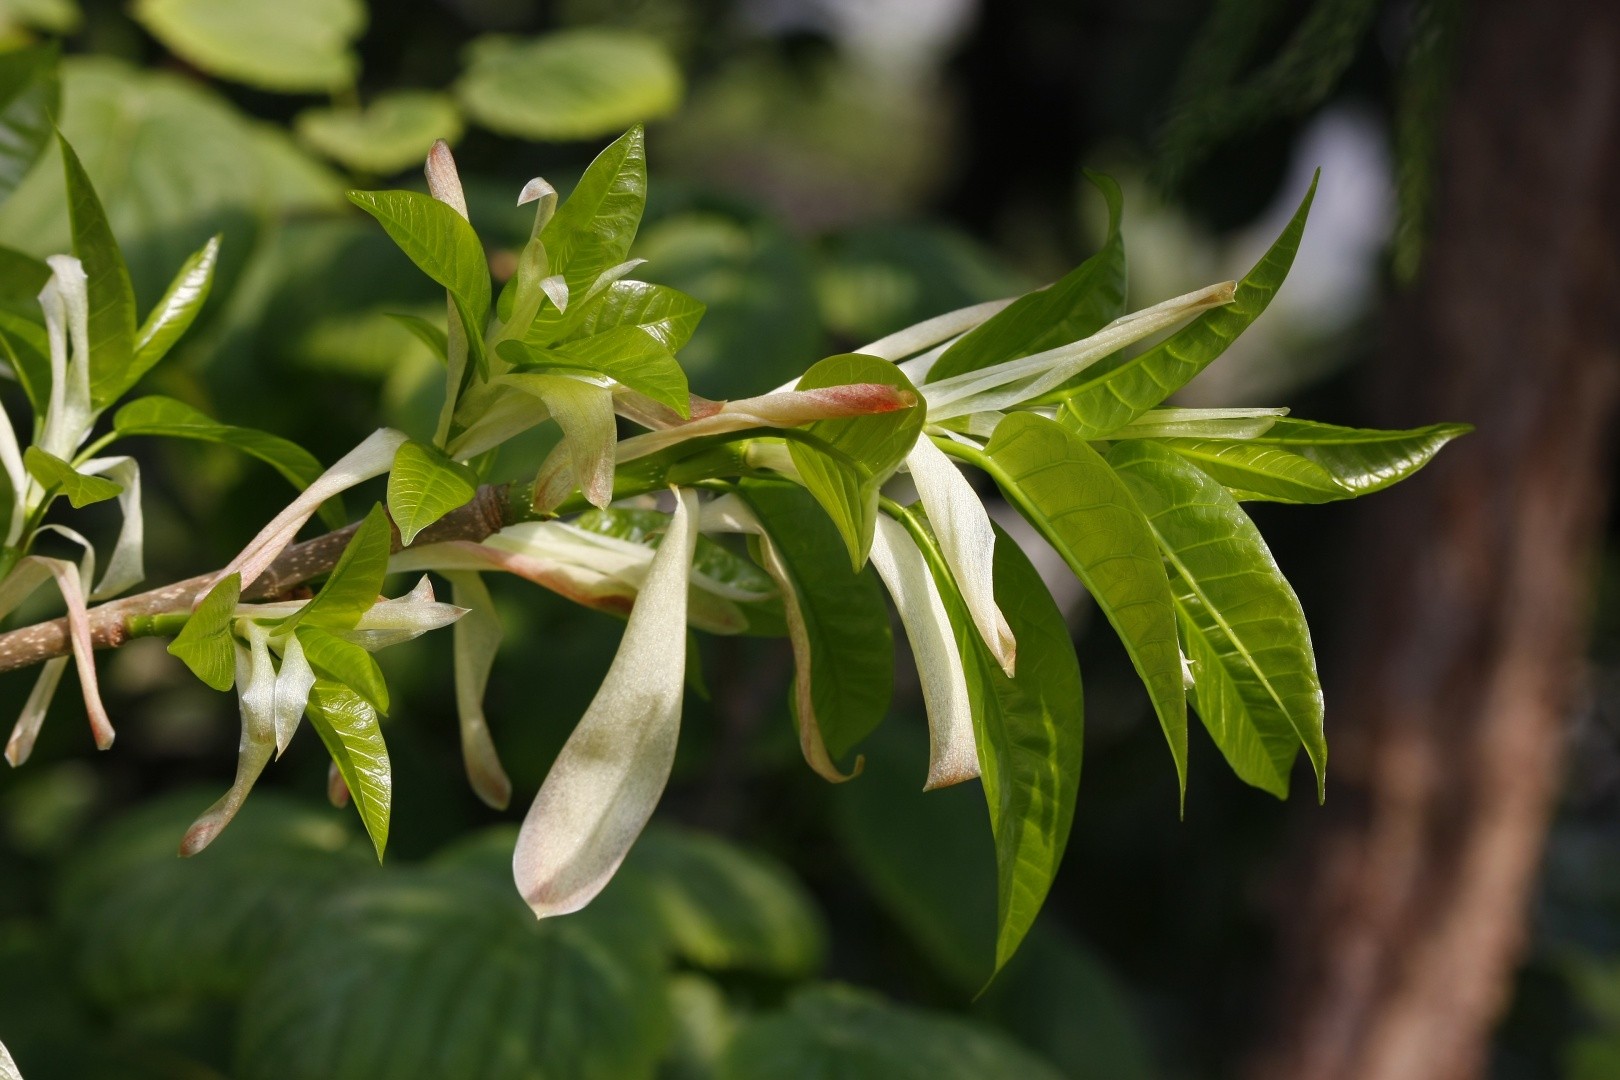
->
<box><xmin>1251</xmin><ymin>0</ymin><xmax>1620</xmax><ymax>1080</ymax></box>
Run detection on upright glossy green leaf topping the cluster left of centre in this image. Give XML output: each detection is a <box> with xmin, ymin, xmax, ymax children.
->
<box><xmin>539</xmin><ymin>126</ymin><xmax>646</xmax><ymax>295</ymax></box>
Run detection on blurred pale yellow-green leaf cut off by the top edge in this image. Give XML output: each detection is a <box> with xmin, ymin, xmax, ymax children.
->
<box><xmin>134</xmin><ymin>0</ymin><xmax>366</xmax><ymax>94</ymax></box>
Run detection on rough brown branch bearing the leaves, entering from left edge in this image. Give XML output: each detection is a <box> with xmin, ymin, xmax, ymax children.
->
<box><xmin>0</xmin><ymin>484</ymin><xmax>518</xmax><ymax>672</ymax></box>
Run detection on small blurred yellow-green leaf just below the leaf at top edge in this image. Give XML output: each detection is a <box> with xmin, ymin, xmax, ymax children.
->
<box><xmin>293</xmin><ymin>91</ymin><xmax>462</xmax><ymax>176</ymax></box>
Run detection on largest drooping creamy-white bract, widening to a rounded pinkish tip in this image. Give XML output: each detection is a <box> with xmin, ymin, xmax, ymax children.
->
<box><xmin>512</xmin><ymin>492</ymin><xmax>698</xmax><ymax>918</ymax></box>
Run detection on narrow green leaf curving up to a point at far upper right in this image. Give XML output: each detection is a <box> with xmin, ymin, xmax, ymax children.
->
<box><xmin>1055</xmin><ymin>180</ymin><xmax>1317</xmax><ymax>439</ymax></box>
